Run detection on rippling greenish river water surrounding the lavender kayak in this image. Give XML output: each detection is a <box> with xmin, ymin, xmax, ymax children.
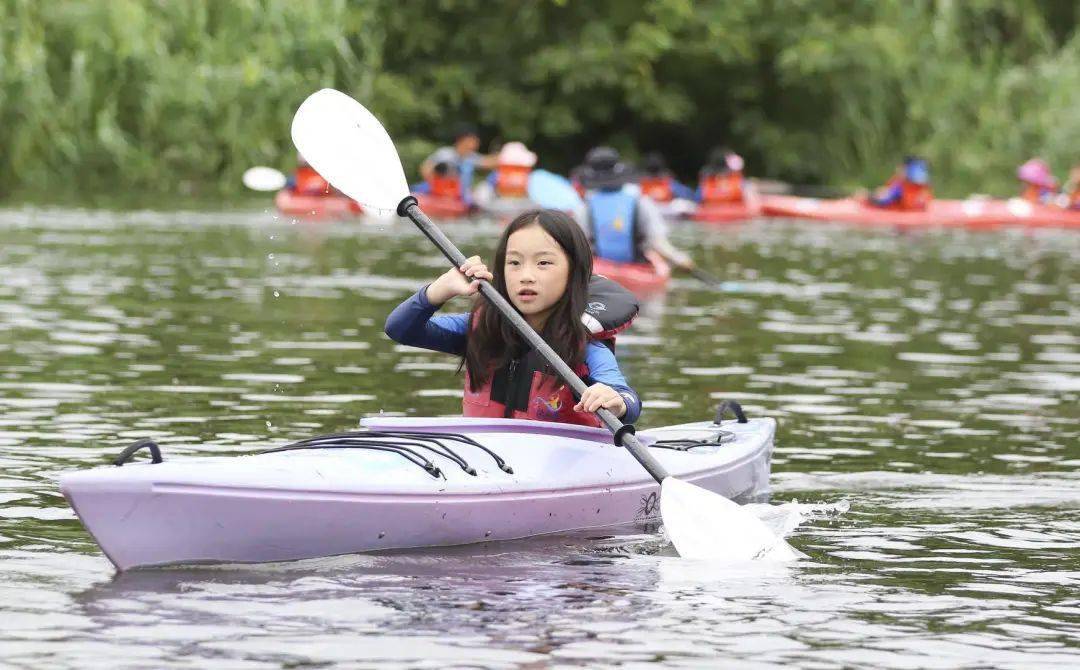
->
<box><xmin>0</xmin><ymin>209</ymin><xmax>1080</xmax><ymax>668</ymax></box>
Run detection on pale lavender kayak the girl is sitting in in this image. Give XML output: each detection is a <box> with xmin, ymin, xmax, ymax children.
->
<box><xmin>60</xmin><ymin>417</ymin><xmax>775</xmax><ymax>571</ymax></box>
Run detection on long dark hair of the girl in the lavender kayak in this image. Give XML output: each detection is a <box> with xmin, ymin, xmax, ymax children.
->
<box><xmin>462</xmin><ymin>210</ymin><xmax>593</xmax><ymax>391</ymax></box>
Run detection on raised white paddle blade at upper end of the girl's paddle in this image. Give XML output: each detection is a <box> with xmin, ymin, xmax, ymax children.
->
<box><xmin>293</xmin><ymin>89</ymin><xmax>408</xmax><ymax>214</ymax></box>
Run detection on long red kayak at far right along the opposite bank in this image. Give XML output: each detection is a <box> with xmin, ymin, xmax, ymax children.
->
<box><xmin>762</xmin><ymin>196</ymin><xmax>1080</xmax><ymax>228</ymax></box>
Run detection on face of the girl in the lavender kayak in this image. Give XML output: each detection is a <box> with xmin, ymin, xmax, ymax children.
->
<box><xmin>502</xmin><ymin>224</ymin><xmax>570</xmax><ymax>331</ymax></box>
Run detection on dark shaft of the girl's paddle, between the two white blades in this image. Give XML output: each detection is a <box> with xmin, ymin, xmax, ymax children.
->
<box><xmin>397</xmin><ymin>196</ymin><xmax>667</xmax><ymax>483</ymax></box>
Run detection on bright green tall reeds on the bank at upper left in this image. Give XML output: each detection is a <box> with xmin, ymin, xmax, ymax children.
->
<box><xmin>0</xmin><ymin>0</ymin><xmax>380</xmax><ymax>197</ymax></box>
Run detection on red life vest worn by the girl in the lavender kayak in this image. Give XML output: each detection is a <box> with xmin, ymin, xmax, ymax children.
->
<box><xmin>461</xmin><ymin>351</ymin><xmax>602</xmax><ymax>427</ymax></box>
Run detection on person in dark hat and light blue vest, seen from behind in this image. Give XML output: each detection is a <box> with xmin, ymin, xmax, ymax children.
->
<box><xmin>575</xmin><ymin>147</ymin><xmax>694</xmax><ymax>270</ymax></box>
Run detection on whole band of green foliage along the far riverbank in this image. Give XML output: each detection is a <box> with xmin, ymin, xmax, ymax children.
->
<box><xmin>0</xmin><ymin>0</ymin><xmax>1080</xmax><ymax>195</ymax></box>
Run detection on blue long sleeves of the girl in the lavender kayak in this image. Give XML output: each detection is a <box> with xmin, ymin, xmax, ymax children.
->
<box><xmin>384</xmin><ymin>286</ymin><xmax>642</xmax><ymax>424</ymax></box>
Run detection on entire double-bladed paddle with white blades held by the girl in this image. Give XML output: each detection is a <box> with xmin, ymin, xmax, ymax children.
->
<box><xmin>293</xmin><ymin>89</ymin><xmax>794</xmax><ymax>560</ymax></box>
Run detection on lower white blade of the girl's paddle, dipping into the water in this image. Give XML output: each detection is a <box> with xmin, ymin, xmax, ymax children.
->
<box><xmin>660</xmin><ymin>477</ymin><xmax>798</xmax><ymax>562</ymax></box>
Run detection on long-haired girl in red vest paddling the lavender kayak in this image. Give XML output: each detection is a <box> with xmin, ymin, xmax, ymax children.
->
<box><xmin>386</xmin><ymin>210</ymin><xmax>642</xmax><ymax>426</ymax></box>
